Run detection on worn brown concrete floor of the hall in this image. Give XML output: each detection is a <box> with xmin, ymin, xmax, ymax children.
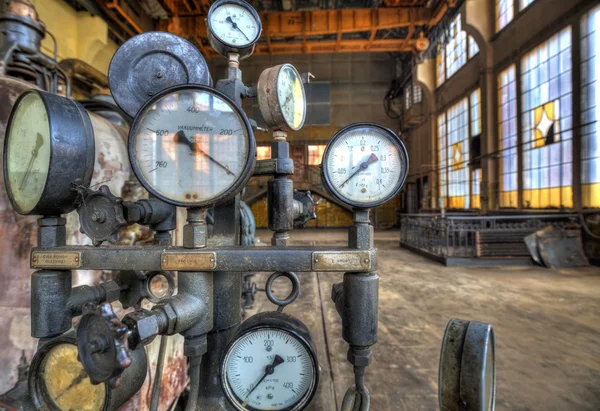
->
<box><xmin>248</xmin><ymin>230</ymin><xmax>600</xmax><ymax>411</ymax></box>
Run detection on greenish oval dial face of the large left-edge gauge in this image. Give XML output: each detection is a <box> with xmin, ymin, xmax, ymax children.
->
<box><xmin>5</xmin><ymin>93</ymin><xmax>51</xmax><ymax>214</ymax></box>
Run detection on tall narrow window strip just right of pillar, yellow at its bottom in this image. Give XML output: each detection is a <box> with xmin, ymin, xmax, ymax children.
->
<box><xmin>498</xmin><ymin>65</ymin><xmax>519</xmax><ymax>208</ymax></box>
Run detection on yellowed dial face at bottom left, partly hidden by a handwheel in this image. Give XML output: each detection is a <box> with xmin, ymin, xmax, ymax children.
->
<box><xmin>38</xmin><ymin>344</ymin><xmax>106</xmax><ymax>411</ymax></box>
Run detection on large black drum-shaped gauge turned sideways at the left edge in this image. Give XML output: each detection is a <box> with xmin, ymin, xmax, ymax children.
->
<box><xmin>4</xmin><ymin>90</ymin><xmax>95</xmax><ymax>215</ymax></box>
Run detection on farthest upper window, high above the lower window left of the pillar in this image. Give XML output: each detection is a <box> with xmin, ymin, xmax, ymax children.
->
<box><xmin>436</xmin><ymin>14</ymin><xmax>479</xmax><ymax>87</ymax></box>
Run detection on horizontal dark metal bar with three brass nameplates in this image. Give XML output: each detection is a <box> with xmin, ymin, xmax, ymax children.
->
<box><xmin>31</xmin><ymin>246</ymin><xmax>377</xmax><ymax>272</ymax></box>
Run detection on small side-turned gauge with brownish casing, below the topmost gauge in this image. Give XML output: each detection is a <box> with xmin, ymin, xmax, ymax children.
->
<box><xmin>257</xmin><ymin>64</ymin><xmax>306</xmax><ymax>131</ymax></box>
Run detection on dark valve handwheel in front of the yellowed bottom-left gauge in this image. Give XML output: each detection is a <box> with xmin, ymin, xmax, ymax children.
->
<box><xmin>77</xmin><ymin>302</ymin><xmax>131</xmax><ymax>389</ymax></box>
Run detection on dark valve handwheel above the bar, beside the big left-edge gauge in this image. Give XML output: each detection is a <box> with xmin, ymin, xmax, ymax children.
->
<box><xmin>77</xmin><ymin>185</ymin><xmax>127</xmax><ymax>247</ymax></box>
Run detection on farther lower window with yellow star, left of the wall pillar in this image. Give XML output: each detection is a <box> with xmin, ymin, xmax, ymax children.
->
<box><xmin>438</xmin><ymin>89</ymin><xmax>481</xmax><ymax>209</ymax></box>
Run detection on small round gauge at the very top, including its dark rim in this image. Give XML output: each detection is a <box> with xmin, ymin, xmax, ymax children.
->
<box><xmin>207</xmin><ymin>0</ymin><xmax>262</xmax><ymax>59</ymax></box>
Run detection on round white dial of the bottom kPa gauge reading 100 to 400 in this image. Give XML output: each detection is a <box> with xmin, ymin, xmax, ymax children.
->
<box><xmin>224</xmin><ymin>328</ymin><xmax>316</xmax><ymax>410</ymax></box>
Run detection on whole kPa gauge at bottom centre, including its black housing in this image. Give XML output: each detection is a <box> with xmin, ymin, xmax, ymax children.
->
<box><xmin>221</xmin><ymin>312</ymin><xmax>319</xmax><ymax>411</ymax></box>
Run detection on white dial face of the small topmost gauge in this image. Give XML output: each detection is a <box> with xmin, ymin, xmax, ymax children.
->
<box><xmin>210</xmin><ymin>2</ymin><xmax>261</xmax><ymax>47</ymax></box>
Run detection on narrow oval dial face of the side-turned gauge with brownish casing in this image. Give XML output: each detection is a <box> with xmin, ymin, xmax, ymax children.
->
<box><xmin>277</xmin><ymin>64</ymin><xmax>306</xmax><ymax>131</ymax></box>
